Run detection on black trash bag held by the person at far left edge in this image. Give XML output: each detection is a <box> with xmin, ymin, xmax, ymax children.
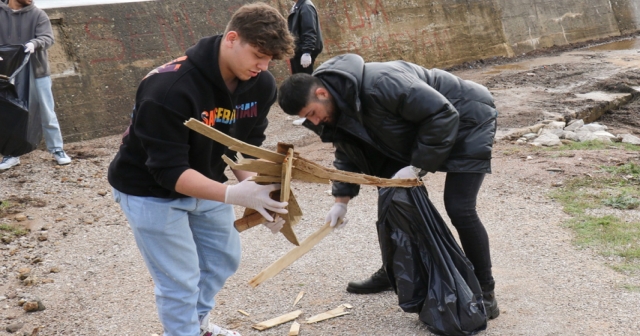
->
<box><xmin>0</xmin><ymin>45</ymin><xmax>42</xmax><ymax>156</ymax></box>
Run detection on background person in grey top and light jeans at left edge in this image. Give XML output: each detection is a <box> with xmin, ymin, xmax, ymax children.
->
<box><xmin>0</xmin><ymin>0</ymin><xmax>71</xmax><ymax>171</ymax></box>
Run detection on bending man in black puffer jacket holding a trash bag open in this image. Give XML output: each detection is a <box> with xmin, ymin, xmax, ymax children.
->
<box><xmin>278</xmin><ymin>54</ymin><xmax>500</xmax><ymax>318</ymax></box>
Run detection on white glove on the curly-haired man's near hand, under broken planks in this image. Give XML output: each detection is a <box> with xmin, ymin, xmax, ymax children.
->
<box><xmin>224</xmin><ymin>179</ymin><xmax>289</xmax><ymax>222</ymax></box>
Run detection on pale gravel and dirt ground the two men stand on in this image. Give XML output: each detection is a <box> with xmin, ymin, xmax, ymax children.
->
<box><xmin>0</xmin><ymin>38</ymin><xmax>640</xmax><ymax>336</ymax></box>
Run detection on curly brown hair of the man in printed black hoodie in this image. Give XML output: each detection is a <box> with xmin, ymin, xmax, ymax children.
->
<box><xmin>224</xmin><ymin>2</ymin><xmax>294</xmax><ymax>60</ymax></box>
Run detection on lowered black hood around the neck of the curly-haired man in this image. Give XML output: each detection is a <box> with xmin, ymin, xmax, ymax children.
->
<box><xmin>186</xmin><ymin>35</ymin><xmax>262</xmax><ymax>95</ymax></box>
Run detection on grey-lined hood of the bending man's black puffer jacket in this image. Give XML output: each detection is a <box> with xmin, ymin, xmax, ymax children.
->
<box><xmin>313</xmin><ymin>54</ymin><xmax>364</xmax><ymax>122</ymax></box>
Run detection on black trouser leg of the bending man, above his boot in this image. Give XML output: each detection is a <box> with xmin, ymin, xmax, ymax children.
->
<box><xmin>444</xmin><ymin>173</ymin><xmax>493</xmax><ymax>285</ymax></box>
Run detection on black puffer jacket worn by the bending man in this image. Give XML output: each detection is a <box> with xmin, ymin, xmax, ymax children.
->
<box><xmin>305</xmin><ymin>54</ymin><xmax>498</xmax><ymax>197</ymax></box>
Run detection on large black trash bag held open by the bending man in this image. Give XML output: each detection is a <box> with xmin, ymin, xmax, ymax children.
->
<box><xmin>377</xmin><ymin>187</ymin><xmax>487</xmax><ymax>335</ymax></box>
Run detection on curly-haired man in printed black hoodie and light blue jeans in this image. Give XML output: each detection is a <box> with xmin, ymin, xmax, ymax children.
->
<box><xmin>109</xmin><ymin>3</ymin><xmax>293</xmax><ymax>336</ymax></box>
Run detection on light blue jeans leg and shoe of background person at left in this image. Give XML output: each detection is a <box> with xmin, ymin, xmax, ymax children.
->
<box><xmin>34</xmin><ymin>76</ymin><xmax>71</xmax><ymax>165</ymax></box>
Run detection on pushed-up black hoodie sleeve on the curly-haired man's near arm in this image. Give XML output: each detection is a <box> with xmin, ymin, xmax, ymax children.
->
<box><xmin>131</xmin><ymin>100</ymin><xmax>190</xmax><ymax>191</ymax></box>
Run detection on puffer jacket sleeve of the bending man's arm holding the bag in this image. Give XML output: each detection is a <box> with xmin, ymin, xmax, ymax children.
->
<box><xmin>374</xmin><ymin>76</ymin><xmax>459</xmax><ymax>172</ymax></box>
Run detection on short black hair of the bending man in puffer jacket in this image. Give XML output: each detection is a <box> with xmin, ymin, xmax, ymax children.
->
<box><xmin>278</xmin><ymin>73</ymin><xmax>324</xmax><ymax>115</ymax></box>
